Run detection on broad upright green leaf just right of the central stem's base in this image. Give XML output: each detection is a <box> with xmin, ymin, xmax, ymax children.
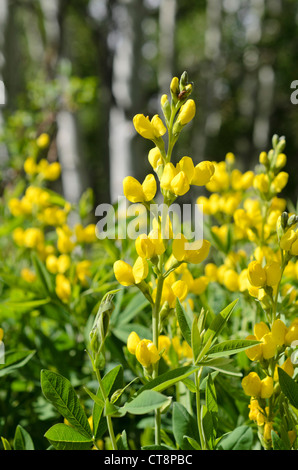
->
<box><xmin>172</xmin><ymin>402</ymin><xmax>200</xmax><ymax>450</ymax></box>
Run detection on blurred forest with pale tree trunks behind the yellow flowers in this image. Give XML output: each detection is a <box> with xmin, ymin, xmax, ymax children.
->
<box><xmin>0</xmin><ymin>0</ymin><xmax>298</xmax><ymax>209</ymax></box>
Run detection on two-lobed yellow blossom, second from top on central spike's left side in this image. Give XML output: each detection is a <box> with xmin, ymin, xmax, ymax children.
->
<box><xmin>123</xmin><ymin>174</ymin><xmax>157</xmax><ymax>203</ymax></box>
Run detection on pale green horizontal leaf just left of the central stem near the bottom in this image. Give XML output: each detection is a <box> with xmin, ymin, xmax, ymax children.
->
<box><xmin>119</xmin><ymin>390</ymin><xmax>171</xmax><ymax>415</ymax></box>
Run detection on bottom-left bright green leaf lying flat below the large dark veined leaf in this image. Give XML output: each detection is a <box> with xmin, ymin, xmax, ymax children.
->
<box><xmin>45</xmin><ymin>423</ymin><xmax>93</xmax><ymax>450</ymax></box>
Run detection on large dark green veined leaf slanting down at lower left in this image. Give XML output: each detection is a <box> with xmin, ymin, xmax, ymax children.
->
<box><xmin>41</xmin><ymin>370</ymin><xmax>92</xmax><ymax>438</ymax></box>
